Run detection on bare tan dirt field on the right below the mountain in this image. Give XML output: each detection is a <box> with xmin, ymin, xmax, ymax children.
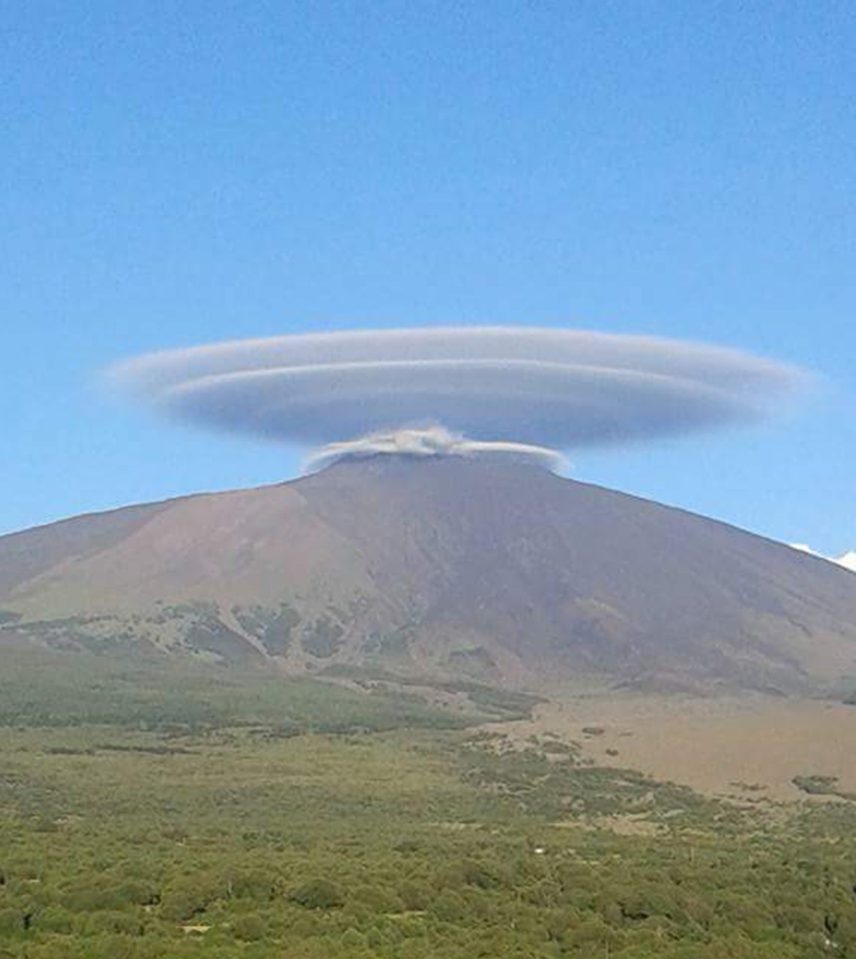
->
<box><xmin>498</xmin><ymin>695</ymin><xmax>856</xmax><ymax>801</ymax></box>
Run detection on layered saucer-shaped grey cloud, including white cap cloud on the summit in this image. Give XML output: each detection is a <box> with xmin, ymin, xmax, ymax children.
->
<box><xmin>112</xmin><ymin>327</ymin><xmax>800</xmax><ymax>461</ymax></box>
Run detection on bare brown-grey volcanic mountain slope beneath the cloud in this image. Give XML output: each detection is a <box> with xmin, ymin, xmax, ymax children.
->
<box><xmin>0</xmin><ymin>457</ymin><xmax>856</xmax><ymax>691</ymax></box>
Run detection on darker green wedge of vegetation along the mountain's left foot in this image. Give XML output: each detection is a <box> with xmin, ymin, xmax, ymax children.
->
<box><xmin>0</xmin><ymin>650</ymin><xmax>474</xmax><ymax>735</ymax></box>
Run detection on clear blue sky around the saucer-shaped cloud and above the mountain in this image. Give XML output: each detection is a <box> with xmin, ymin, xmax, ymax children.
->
<box><xmin>0</xmin><ymin>0</ymin><xmax>856</xmax><ymax>553</ymax></box>
